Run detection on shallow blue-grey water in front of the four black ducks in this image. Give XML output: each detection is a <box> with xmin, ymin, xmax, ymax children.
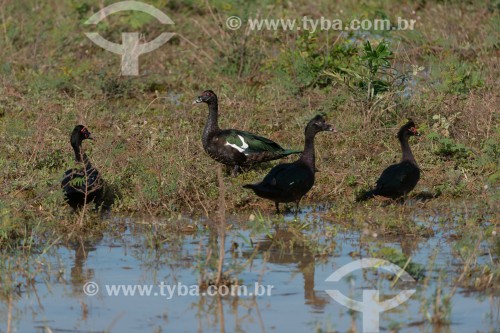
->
<box><xmin>0</xmin><ymin>210</ymin><xmax>500</xmax><ymax>332</ymax></box>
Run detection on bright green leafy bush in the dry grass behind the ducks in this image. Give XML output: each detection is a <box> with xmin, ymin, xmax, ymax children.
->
<box><xmin>273</xmin><ymin>32</ymin><xmax>395</xmax><ymax>98</ymax></box>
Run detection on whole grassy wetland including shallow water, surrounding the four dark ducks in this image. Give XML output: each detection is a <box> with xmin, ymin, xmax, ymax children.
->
<box><xmin>0</xmin><ymin>0</ymin><xmax>500</xmax><ymax>332</ymax></box>
